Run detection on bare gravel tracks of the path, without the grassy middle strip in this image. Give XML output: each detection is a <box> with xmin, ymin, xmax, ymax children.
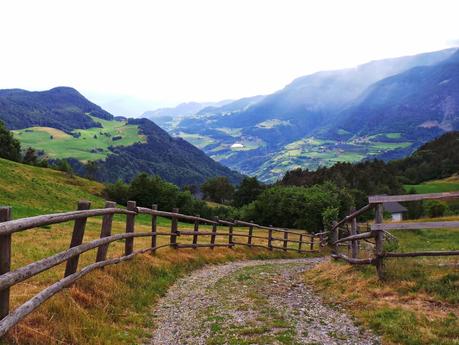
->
<box><xmin>148</xmin><ymin>258</ymin><xmax>380</xmax><ymax>345</ymax></box>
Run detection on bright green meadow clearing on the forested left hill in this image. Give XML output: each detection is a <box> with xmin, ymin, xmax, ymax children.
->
<box><xmin>13</xmin><ymin>117</ymin><xmax>146</xmax><ymax>161</ymax></box>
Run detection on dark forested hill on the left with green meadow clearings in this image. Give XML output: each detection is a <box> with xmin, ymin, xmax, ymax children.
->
<box><xmin>0</xmin><ymin>88</ymin><xmax>241</xmax><ymax>186</ymax></box>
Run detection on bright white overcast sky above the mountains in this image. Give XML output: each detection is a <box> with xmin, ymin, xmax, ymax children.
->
<box><xmin>0</xmin><ymin>0</ymin><xmax>459</xmax><ymax>116</ymax></box>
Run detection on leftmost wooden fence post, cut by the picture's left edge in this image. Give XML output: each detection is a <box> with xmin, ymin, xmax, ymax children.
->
<box><xmin>0</xmin><ymin>207</ymin><xmax>13</xmax><ymax>319</ymax></box>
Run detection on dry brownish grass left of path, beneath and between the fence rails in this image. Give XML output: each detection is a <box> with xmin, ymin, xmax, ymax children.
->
<box><xmin>2</xmin><ymin>216</ymin><xmax>312</xmax><ymax>344</ymax></box>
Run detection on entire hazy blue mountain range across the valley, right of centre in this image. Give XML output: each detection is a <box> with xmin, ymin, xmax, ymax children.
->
<box><xmin>158</xmin><ymin>48</ymin><xmax>459</xmax><ymax>181</ymax></box>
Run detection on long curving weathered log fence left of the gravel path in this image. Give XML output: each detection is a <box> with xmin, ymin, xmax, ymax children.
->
<box><xmin>0</xmin><ymin>201</ymin><xmax>320</xmax><ymax>337</ymax></box>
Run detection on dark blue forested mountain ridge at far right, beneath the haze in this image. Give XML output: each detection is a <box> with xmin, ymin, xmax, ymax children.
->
<box><xmin>338</xmin><ymin>51</ymin><xmax>459</xmax><ymax>139</ymax></box>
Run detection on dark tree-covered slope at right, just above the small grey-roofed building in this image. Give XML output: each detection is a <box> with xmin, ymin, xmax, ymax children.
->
<box><xmin>280</xmin><ymin>132</ymin><xmax>459</xmax><ymax>206</ymax></box>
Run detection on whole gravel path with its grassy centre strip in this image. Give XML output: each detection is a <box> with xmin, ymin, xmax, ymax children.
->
<box><xmin>150</xmin><ymin>258</ymin><xmax>380</xmax><ymax>345</ymax></box>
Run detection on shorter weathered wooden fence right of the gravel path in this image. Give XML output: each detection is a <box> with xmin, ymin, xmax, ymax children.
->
<box><xmin>330</xmin><ymin>192</ymin><xmax>459</xmax><ymax>279</ymax></box>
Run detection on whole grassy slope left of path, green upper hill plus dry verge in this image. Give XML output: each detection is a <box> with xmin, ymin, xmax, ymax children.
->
<box><xmin>0</xmin><ymin>159</ymin><xmax>310</xmax><ymax>345</ymax></box>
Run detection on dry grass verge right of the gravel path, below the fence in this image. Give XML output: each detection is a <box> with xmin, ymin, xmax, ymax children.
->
<box><xmin>305</xmin><ymin>217</ymin><xmax>459</xmax><ymax>345</ymax></box>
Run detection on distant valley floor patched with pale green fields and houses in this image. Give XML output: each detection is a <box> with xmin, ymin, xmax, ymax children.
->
<box><xmin>171</xmin><ymin>124</ymin><xmax>414</xmax><ymax>182</ymax></box>
